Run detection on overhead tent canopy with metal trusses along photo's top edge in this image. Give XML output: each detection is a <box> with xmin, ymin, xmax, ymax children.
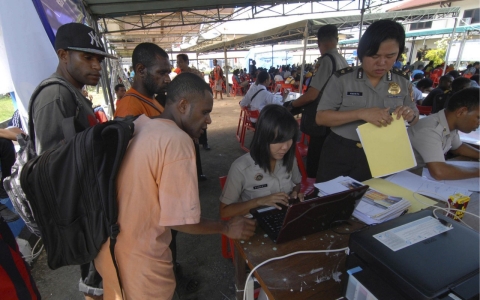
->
<box><xmin>83</xmin><ymin>0</ymin><xmax>402</xmax><ymax>57</ymax></box>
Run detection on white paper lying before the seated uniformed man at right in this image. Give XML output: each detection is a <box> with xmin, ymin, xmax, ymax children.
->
<box><xmin>386</xmin><ymin>171</ymin><xmax>472</xmax><ymax>201</ymax></box>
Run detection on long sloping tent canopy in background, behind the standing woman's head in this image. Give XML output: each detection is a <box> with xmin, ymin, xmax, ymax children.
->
<box><xmin>192</xmin><ymin>7</ymin><xmax>460</xmax><ymax>53</ymax></box>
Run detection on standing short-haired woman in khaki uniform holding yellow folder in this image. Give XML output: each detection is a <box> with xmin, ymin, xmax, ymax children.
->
<box><xmin>316</xmin><ymin>20</ymin><xmax>418</xmax><ymax>182</ymax></box>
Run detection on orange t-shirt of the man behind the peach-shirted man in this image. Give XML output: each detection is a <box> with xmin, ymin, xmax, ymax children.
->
<box><xmin>114</xmin><ymin>88</ymin><xmax>164</xmax><ymax>117</ymax></box>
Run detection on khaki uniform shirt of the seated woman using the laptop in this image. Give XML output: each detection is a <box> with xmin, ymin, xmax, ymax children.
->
<box><xmin>220</xmin><ymin>153</ymin><xmax>302</xmax><ymax>205</ymax></box>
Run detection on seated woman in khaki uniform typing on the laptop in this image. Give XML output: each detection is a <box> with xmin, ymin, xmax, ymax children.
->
<box><xmin>220</xmin><ymin>104</ymin><xmax>303</xmax><ymax>218</ymax></box>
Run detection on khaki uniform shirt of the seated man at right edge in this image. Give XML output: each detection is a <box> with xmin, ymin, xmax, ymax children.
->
<box><xmin>408</xmin><ymin>109</ymin><xmax>462</xmax><ymax>167</ymax></box>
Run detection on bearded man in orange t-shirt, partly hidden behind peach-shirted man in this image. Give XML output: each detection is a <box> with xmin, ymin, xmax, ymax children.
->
<box><xmin>114</xmin><ymin>43</ymin><xmax>171</xmax><ymax>117</ymax></box>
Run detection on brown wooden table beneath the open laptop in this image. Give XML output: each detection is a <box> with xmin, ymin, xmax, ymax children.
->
<box><xmin>234</xmin><ymin>218</ymin><xmax>363</xmax><ymax>300</ymax></box>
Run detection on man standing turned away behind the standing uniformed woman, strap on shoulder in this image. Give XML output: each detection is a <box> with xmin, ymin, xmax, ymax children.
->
<box><xmin>284</xmin><ymin>25</ymin><xmax>348</xmax><ymax>178</ymax></box>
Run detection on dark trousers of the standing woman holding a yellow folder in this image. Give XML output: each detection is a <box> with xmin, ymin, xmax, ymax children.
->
<box><xmin>317</xmin><ymin>132</ymin><xmax>372</xmax><ymax>182</ymax></box>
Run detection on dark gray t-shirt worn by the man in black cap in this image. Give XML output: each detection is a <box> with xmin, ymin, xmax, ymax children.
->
<box><xmin>30</xmin><ymin>73</ymin><xmax>97</xmax><ymax>154</ymax></box>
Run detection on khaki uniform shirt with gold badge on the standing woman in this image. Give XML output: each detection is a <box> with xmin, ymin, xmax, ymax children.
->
<box><xmin>317</xmin><ymin>67</ymin><xmax>418</xmax><ymax>141</ymax></box>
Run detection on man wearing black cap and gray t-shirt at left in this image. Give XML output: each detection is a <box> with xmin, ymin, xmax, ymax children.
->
<box><xmin>29</xmin><ymin>23</ymin><xmax>116</xmax><ymax>299</ymax></box>
